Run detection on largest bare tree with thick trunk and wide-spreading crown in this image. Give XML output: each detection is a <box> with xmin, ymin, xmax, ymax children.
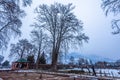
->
<box><xmin>34</xmin><ymin>3</ymin><xmax>88</xmax><ymax>70</ymax></box>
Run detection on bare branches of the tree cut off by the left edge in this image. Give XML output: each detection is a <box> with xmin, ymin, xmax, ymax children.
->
<box><xmin>0</xmin><ymin>0</ymin><xmax>32</xmax><ymax>49</ymax></box>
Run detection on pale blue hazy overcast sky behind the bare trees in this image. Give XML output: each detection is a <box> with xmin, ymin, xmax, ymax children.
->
<box><xmin>9</xmin><ymin>0</ymin><xmax>120</xmax><ymax>59</ymax></box>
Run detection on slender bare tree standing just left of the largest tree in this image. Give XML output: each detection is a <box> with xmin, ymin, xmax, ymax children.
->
<box><xmin>31</xmin><ymin>28</ymin><xmax>48</xmax><ymax>68</ymax></box>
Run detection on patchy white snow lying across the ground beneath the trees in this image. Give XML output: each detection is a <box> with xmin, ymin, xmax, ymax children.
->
<box><xmin>0</xmin><ymin>68</ymin><xmax>120</xmax><ymax>80</ymax></box>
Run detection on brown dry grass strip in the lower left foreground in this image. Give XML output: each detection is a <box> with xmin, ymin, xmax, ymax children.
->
<box><xmin>0</xmin><ymin>72</ymin><xmax>74</xmax><ymax>80</ymax></box>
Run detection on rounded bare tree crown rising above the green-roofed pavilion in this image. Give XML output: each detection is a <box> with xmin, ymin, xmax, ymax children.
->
<box><xmin>9</xmin><ymin>39</ymin><xmax>36</xmax><ymax>58</ymax></box>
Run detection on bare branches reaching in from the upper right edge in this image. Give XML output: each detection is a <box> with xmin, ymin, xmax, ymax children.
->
<box><xmin>102</xmin><ymin>0</ymin><xmax>120</xmax><ymax>34</ymax></box>
